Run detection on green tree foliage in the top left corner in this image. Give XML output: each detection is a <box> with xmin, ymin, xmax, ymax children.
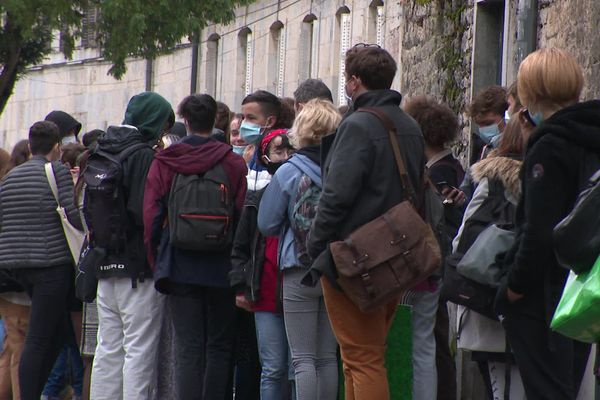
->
<box><xmin>0</xmin><ymin>0</ymin><xmax>253</xmax><ymax>113</ymax></box>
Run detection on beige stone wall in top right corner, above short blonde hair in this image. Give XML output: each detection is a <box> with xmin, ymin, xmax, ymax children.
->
<box><xmin>538</xmin><ymin>0</ymin><xmax>600</xmax><ymax>100</ymax></box>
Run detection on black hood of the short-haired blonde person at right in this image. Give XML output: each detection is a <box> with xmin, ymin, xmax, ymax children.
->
<box><xmin>527</xmin><ymin>100</ymin><xmax>600</xmax><ymax>153</ymax></box>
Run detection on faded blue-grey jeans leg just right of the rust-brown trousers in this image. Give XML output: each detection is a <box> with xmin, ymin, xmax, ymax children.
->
<box><xmin>412</xmin><ymin>289</ymin><xmax>440</xmax><ymax>400</ymax></box>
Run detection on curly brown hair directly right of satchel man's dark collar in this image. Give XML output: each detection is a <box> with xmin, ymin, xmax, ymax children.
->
<box><xmin>404</xmin><ymin>95</ymin><xmax>458</xmax><ymax>149</ymax></box>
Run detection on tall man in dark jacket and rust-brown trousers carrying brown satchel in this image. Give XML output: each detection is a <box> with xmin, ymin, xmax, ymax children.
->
<box><xmin>304</xmin><ymin>44</ymin><xmax>426</xmax><ymax>400</ymax></box>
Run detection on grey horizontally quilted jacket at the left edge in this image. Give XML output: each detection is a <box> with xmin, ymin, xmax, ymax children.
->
<box><xmin>0</xmin><ymin>156</ymin><xmax>81</xmax><ymax>269</ymax></box>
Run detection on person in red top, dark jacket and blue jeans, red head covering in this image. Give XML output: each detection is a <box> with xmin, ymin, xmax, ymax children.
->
<box><xmin>229</xmin><ymin>129</ymin><xmax>293</xmax><ymax>400</ymax></box>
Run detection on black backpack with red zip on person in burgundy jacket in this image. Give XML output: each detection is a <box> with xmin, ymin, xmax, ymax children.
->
<box><xmin>168</xmin><ymin>163</ymin><xmax>235</xmax><ymax>252</ymax></box>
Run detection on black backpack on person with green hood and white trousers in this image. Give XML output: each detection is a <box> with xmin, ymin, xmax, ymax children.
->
<box><xmin>83</xmin><ymin>143</ymin><xmax>149</xmax><ymax>254</ymax></box>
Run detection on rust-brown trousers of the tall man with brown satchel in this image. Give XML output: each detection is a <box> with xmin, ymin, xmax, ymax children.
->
<box><xmin>321</xmin><ymin>277</ymin><xmax>399</xmax><ymax>400</ymax></box>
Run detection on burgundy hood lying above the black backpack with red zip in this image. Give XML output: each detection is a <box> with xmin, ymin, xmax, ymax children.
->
<box><xmin>155</xmin><ymin>140</ymin><xmax>231</xmax><ymax>174</ymax></box>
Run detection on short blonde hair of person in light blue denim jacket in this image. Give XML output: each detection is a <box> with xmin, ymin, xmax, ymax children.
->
<box><xmin>290</xmin><ymin>99</ymin><xmax>342</xmax><ymax>148</ymax></box>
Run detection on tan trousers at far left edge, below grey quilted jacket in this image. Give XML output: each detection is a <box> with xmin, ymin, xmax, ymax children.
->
<box><xmin>0</xmin><ymin>298</ymin><xmax>30</xmax><ymax>400</ymax></box>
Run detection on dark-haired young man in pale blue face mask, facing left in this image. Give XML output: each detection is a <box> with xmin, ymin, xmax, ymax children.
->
<box><xmin>240</xmin><ymin>90</ymin><xmax>293</xmax><ymax>190</ymax></box>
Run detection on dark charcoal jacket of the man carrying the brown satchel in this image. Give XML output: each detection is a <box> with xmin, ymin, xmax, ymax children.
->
<box><xmin>304</xmin><ymin>90</ymin><xmax>425</xmax><ymax>283</ymax></box>
